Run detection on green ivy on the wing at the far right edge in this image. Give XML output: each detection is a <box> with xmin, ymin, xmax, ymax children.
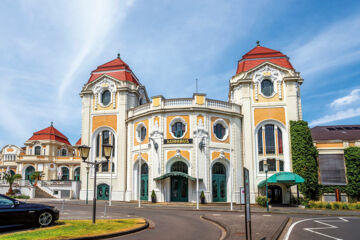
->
<box><xmin>344</xmin><ymin>147</ymin><xmax>360</xmax><ymax>201</ymax></box>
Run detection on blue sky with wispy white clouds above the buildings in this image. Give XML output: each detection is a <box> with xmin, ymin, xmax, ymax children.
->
<box><xmin>0</xmin><ymin>0</ymin><xmax>360</xmax><ymax>146</ymax></box>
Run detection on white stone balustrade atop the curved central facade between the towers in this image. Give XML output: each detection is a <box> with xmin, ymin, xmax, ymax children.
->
<box><xmin>128</xmin><ymin>93</ymin><xmax>241</xmax><ymax>118</ymax></box>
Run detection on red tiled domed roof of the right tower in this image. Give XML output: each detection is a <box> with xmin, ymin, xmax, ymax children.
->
<box><xmin>236</xmin><ymin>45</ymin><xmax>294</xmax><ymax>74</ymax></box>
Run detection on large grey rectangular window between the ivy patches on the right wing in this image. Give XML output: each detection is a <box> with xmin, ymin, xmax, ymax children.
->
<box><xmin>319</xmin><ymin>154</ymin><xmax>346</xmax><ymax>185</ymax></box>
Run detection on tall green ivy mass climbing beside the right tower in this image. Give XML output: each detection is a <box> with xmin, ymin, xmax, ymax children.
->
<box><xmin>290</xmin><ymin>120</ymin><xmax>319</xmax><ymax>200</ymax></box>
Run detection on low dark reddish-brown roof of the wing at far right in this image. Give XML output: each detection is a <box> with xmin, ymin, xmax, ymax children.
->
<box><xmin>311</xmin><ymin>125</ymin><xmax>360</xmax><ymax>141</ymax></box>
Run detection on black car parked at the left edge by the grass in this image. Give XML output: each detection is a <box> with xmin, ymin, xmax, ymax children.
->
<box><xmin>0</xmin><ymin>194</ymin><xmax>59</xmax><ymax>228</ymax></box>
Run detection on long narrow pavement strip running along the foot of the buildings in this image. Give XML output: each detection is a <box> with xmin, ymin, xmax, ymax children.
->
<box><xmin>26</xmin><ymin>198</ymin><xmax>360</xmax><ymax>217</ymax></box>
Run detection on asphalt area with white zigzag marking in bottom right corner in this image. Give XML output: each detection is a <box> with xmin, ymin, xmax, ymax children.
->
<box><xmin>284</xmin><ymin>216</ymin><xmax>360</xmax><ymax>240</ymax></box>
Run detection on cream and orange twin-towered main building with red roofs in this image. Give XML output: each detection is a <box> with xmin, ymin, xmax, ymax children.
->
<box><xmin>80</xmin><ymin>45</ymin><xmax>303</xmax><ymax>203</ymax></box>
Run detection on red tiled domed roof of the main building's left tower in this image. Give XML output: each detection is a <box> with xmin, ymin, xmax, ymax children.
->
<box><xmin>88</xmin><ymin>54</ymin><xmax>140</xmax><ymax>85</ymax></box>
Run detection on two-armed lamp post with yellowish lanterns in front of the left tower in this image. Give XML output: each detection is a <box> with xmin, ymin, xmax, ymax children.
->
<box><xmin>78</xmin><ymin>144</ymin><xmax>112</xmax><ymax>224</ymax></box>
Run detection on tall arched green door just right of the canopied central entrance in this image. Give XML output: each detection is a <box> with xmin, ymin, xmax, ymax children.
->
<box><xmin>212</xmin><ymin>162</ymin><xmax>226</xmax><ymax>202</ymax></box>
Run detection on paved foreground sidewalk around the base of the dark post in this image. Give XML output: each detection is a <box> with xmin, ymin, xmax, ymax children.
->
<box><xmin>203</xmin><ymin>213</ymin><xmax>288</xmax><ymax>240</ymax></box>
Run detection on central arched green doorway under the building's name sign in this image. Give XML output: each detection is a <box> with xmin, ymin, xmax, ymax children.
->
<box><xmin>170</xmin><ymin>161</ymin><xmax>188</xmax><ymax>202</ymax></box>
